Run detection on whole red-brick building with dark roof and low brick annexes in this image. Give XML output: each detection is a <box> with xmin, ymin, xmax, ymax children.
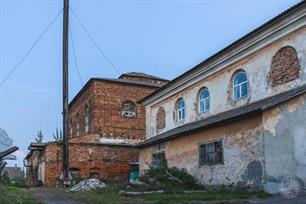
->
<box><xmin>25</xmin><ymin>72</ymin><xmax>168</xmax><ymax>186</ymax></box>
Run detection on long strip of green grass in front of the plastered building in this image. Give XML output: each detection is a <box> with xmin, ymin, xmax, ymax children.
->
<box><xmin>69</xmin><ymin>184</ymin><xmax>269</xmax><ymax>204</ymax></box>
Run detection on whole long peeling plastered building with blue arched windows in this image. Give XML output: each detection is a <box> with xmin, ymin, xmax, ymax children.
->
<box><xmin>137</xmin><ymin>1</ymin><xmax>306</xmax><ymax>193</ymax></box>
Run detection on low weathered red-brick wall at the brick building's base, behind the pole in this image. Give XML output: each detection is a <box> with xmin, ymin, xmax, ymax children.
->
<box><xmin>45</xmin><ymin>143</ymin><xmax>138</xmax><ymax>186</ymax></box>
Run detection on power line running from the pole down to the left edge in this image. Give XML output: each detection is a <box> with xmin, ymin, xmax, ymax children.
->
<box><xmin>0</xmin><ymin>9</ymin><xmax>63</xmax><ymax>88</ymax></box>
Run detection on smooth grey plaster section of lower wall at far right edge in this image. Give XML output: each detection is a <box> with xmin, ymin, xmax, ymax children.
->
<box><xmin>263</xmin><ymin>94</ymin><xmax>306</xmax><ymax>193</ymax></box>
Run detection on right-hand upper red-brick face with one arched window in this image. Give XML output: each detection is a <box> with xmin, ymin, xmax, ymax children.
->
<box><xmin>92</xmin><ymin>81</ymin><xmax>156</xmax><ymax>139</ymax></box>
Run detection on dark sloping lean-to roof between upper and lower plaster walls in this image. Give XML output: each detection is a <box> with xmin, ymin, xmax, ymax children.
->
<box><xmin>136</xmin><ymin>85</ymin><xmax>306</xmax><ymax>148</ymax></box>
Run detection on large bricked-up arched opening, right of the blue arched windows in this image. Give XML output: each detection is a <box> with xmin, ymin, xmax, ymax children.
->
<box><xmin>268</xmin><ymin>46</ymin><xmax>299</xmax><ymax>87</ymax></box>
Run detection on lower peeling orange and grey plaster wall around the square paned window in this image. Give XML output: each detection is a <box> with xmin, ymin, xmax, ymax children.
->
<box><xmin>139</xmin><ymin>115</ymin><xmax>264</xmax><ymax>187</ymax></box>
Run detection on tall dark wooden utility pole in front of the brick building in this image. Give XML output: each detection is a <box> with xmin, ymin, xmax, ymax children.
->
<box><xmin>62</xmin><ymin>0</ymin><xmax>69</xmax><ymax>184</ymax></box>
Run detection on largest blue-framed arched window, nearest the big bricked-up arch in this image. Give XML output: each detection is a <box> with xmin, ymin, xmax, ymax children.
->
<box><xmin>233</xmin><ymin>70</ymin><xmax>248</xmax><ymax>100</ymax></box>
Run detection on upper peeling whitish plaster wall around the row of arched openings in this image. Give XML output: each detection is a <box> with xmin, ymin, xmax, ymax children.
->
<box><xmin>146</xmin><ymin>27</ymin><xmax>306</xmax><ymax>138</ymax></box>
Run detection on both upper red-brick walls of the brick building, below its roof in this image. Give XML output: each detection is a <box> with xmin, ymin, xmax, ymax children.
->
<box><xmin>69</xmin><ymin>80</ymin><xmax>157</xmax><ymax>139</ymax></box>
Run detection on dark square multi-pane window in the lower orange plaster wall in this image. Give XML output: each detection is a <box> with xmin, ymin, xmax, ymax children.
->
<box><xmin>199</xmin><ymin>140</ymin><xmax>223</xmax><ymax>166</ymax></box>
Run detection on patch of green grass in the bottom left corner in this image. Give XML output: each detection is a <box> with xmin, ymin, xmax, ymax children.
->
<box><xmin>0</xmin><ymin>186</ymin><xmax>40</xmax><ymax>204</ymax></box>
